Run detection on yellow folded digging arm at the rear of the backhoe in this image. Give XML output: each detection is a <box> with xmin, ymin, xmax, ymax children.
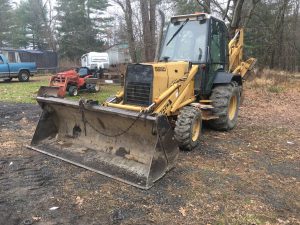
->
<box><xmin>228</xmin><ymin>28</ymin><xmax>257</xmax><ymax>77</ymax></box>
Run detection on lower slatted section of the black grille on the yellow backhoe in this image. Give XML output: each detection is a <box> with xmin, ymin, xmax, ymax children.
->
<box><xmin>126</xmin><ymin>82</ymin><xmax>152</xmax><ymax>106</ymax></box>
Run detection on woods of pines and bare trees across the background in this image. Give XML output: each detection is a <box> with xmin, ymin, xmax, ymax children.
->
<box><xmin>0</xmin><ymin>0</ymin><xmax>300</xmax><ymax>71</ymax></box>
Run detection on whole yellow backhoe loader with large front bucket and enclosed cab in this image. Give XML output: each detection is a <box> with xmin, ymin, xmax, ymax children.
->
<box><xmin>28</xmin><ymin>13</ymin><xmax>256</xmax><ymax>189</ymax></box>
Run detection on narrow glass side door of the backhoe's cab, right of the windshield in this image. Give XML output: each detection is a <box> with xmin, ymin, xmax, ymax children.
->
<box><xmin>202</xmin><ymin>18</ymin><xmax>228</xmax><ymax>95</ymax></box>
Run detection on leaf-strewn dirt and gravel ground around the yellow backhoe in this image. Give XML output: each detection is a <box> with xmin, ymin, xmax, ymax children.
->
<box><xmin>0</xmin><ymin>82</ymin><xmax>300</xmax><ymax>225</ymax></box>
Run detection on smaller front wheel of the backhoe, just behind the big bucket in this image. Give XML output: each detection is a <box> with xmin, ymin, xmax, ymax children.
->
<box><xmin>175</xmin><ymin>106</ymin><xmax>202</xmax><ymax>151</ymax></box>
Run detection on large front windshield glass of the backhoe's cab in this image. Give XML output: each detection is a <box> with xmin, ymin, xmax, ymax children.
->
<box><xmin>160</xmin><ymin>20</ymin><xmax>207</xmax><ymax>63</ymax></box>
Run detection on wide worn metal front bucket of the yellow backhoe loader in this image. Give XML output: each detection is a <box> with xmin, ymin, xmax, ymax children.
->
<box><xmin>28</xmin><ymin>97</ymin><xmax>178</xmax><ymax>189</ymax></box>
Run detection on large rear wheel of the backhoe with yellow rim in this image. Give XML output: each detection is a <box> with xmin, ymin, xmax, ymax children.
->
<box><xmin>208</xmin><ymin>82</ymin><xmax>240</xmax><ymax>131</ymax></box>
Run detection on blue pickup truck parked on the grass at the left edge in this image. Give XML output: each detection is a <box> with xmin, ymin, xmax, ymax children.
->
<box><xmin>0</xmin><ymin>54</ymin><xmax>37</xmax><ymax>82</ymax></box>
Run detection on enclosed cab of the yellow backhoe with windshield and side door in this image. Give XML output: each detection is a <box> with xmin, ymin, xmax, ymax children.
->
<box><xmin>160</xmin><ymin>13</ymin><xmax>232</xmax><ymax>96</ymax></box>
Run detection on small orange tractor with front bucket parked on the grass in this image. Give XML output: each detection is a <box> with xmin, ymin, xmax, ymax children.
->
<box><xmin>38</xmin><ymin>67</ymin><xmax>103</xmax><ymax>98</ymax></box>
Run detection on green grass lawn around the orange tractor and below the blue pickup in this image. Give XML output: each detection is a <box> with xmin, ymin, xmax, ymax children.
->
<box><xmin>0</xmin><ymin>76</ymin><xmax>121</xmax><ymax>103</ymax></box>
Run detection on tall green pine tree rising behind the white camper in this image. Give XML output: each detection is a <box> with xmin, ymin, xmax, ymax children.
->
<box><xmin>57</xmin><ymin>0</ymin><xmax>108</xmax><ymax>60</ymax></box>
